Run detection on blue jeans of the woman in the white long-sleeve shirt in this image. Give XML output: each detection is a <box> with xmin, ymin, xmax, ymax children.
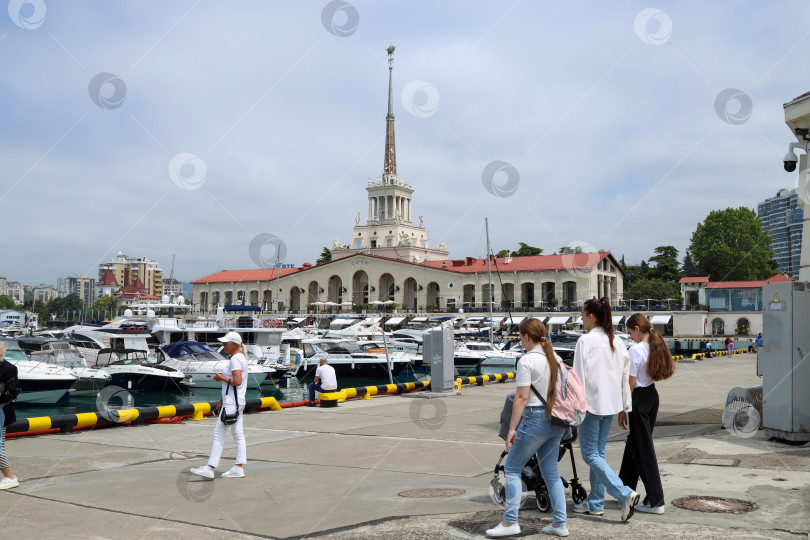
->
<box><xmin>579</xmin><ymin>412</ymin><xmax>633</xmax><ymax>512</ymax></box>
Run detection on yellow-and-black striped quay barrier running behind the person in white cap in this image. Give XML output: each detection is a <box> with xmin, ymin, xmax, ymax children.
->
<box><xmin>6</xmin><ymin>397</ymin><xmax>282</xmax><ymax>435</ymax></box>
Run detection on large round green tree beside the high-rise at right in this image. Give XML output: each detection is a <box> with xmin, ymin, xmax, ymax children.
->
<box><xmin>689</xmin><ymin>207</ymin><xmax>773</xmax><ymax>281</ymax></box>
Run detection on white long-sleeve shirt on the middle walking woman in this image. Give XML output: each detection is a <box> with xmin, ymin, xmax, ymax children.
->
<box><xmin>574</xmin><ymin>326</ymin><xmax>633</xmax><ymax>416</ymax></box>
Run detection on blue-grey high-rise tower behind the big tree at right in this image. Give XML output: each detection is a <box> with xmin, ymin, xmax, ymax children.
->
<box><xmin>757</xmin><ymin>189</ymin><xmax>803</xmax><ymax>279</ymax></box>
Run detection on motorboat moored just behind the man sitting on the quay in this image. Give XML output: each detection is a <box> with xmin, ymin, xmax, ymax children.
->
<box><xmin>293</xmin><ymin>338</ymin><xmax>421</xmax><ymax>380</ymax></box>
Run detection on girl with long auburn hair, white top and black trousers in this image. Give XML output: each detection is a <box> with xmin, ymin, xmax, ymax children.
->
<box><xmin>619</xmin><ymin>313</ymin><xmax>675</xmax><ymax>514</ymax></box>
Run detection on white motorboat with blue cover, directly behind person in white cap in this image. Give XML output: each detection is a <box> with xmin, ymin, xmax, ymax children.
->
<box><xmin>158</xmin><ymin>341</ymin><xmax>267</xmax><ymax>388</ymax></box>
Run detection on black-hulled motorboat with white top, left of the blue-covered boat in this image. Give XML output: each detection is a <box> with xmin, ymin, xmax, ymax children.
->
<box><xmin>93</xmin><ymin>348</ymin><xmax>191</xmax><ymax>392</ymax></box>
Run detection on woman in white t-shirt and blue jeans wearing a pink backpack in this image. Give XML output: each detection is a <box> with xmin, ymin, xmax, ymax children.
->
<box><xmin>487</xmin><ymin>319</ymin><xmax>568</xmax><ymax>537</ymax></box>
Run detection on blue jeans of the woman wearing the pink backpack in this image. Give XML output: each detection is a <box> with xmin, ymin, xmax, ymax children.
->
<box><xmin>503</xmin><ymin>406</ymin><xmax>566</xmax><ymax>527</ymax></box>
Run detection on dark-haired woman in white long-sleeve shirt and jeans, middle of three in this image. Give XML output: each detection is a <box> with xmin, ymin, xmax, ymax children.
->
<box><xmin>574</xmin><ymin>297</ymin><xmax>639</xmax><ymax>521</ymax></box>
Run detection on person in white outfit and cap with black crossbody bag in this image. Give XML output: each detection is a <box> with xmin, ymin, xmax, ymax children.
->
<box><xmin>190</xmin><ymin>332</ymin><xmax>248</xmax><ymax>478</ymax></box>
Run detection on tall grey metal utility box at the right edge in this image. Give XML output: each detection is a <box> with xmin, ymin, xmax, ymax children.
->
<box><xmin>757</xmin><ymin>282</ymin><xmax>810</xmax><ymax>441</ymax></box>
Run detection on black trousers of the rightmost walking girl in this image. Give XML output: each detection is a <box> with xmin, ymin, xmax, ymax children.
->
<box><xmin>619</xmin><ymin>384</ymin><xmax>664</xmax><ymax>507</ymax></box>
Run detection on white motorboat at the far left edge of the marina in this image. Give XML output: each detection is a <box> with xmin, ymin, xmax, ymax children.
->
<box><xmin>2</xmin><ymin>339</ymin><xmax>77</xmax><ymax>405</ymax></box>
